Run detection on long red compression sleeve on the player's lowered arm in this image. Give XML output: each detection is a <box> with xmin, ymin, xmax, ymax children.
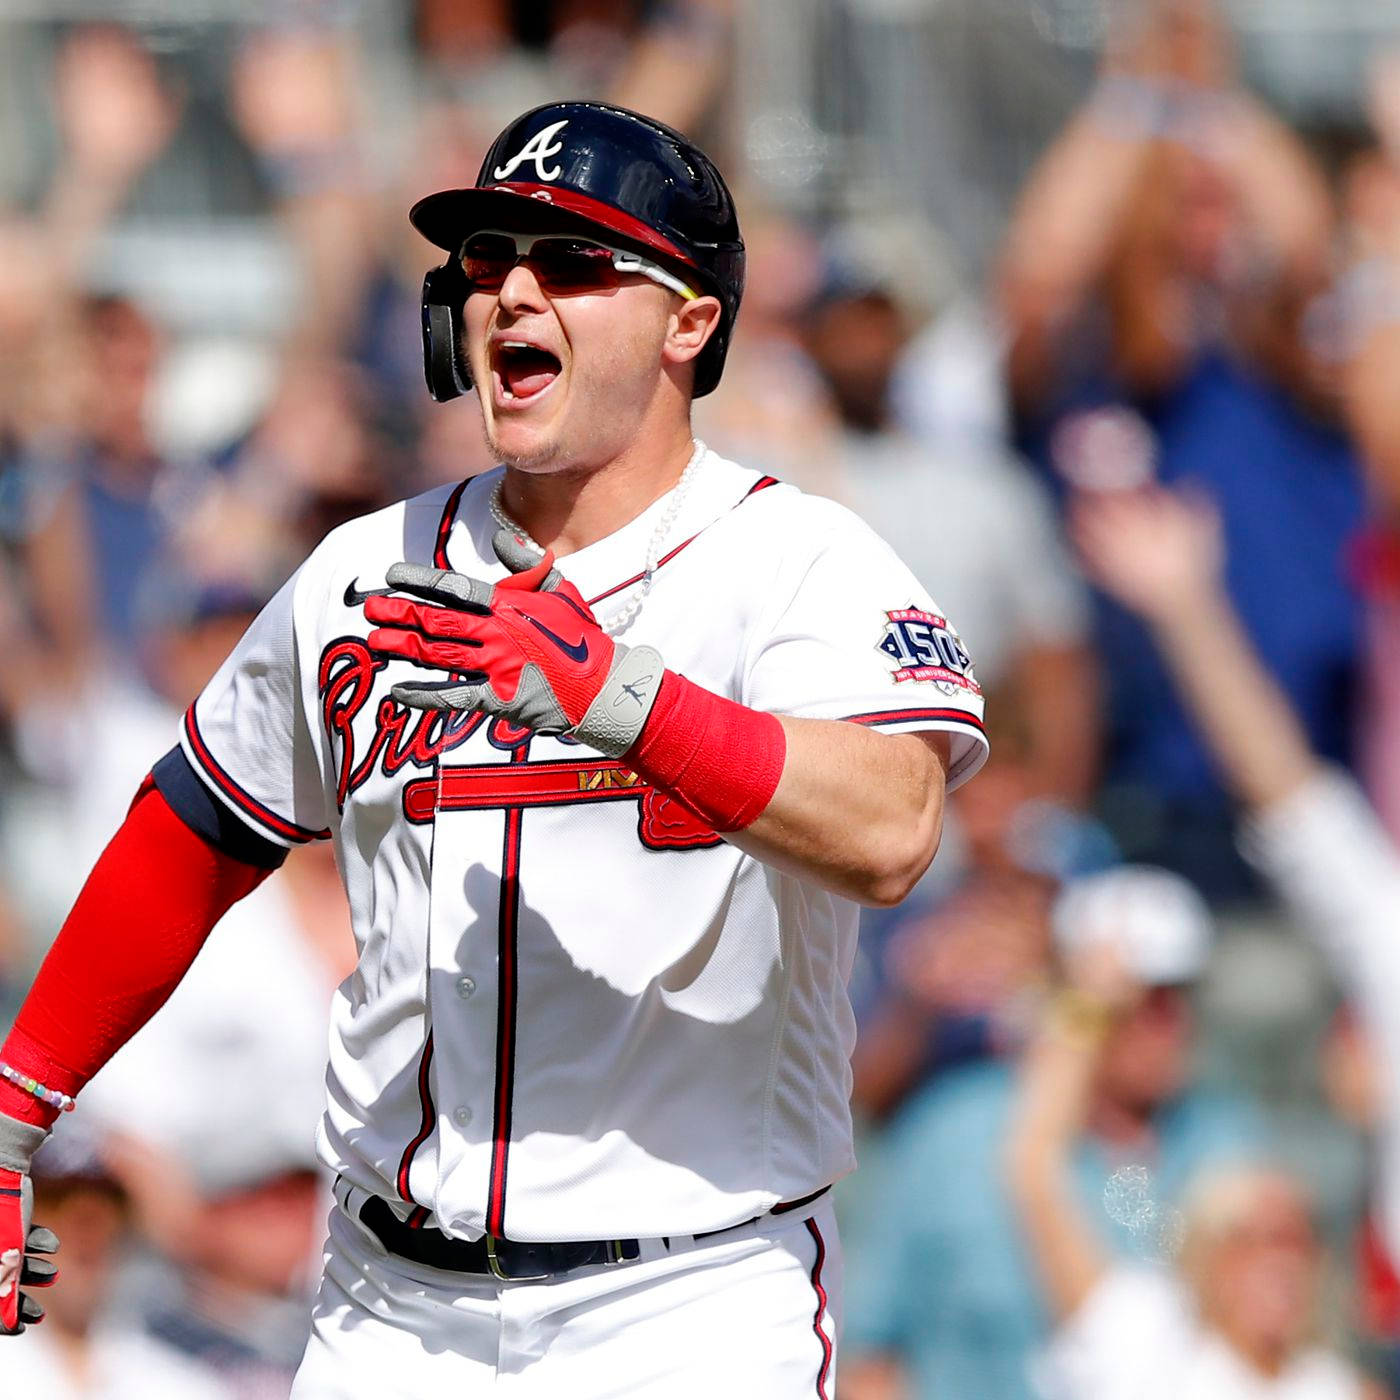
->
<box><xmin>0</xmin><ymin>778</ymin><xmax>270</xmax><ymax>1127</ymax></box>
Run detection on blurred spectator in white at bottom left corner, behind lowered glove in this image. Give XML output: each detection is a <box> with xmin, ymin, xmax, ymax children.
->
<box><xmin>4</xmin><ymin>1126</ymin><xmax>235</xmax><ymax>1400</ymax></box>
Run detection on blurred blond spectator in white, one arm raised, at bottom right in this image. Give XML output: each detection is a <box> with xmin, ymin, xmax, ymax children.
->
<box><xmin>1007</xmin><ymin>939</ymin><xmax>1380</xmax><ymax>1400</ymax></box>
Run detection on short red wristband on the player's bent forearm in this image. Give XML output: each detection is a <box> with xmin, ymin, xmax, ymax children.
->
<box><xmin>624</xmin><ymin>671</ymin><xmax>787</xmax><ymax>832</ymax></box>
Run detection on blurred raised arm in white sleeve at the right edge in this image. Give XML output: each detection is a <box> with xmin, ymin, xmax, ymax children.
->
<box><xmin>1075</xmin><ymin>491</ymin><xmax>1400</xmax><ymax>1383</ymax></box>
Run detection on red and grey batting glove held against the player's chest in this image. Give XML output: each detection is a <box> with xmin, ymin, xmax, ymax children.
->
<box><xmin>364</xmin><ymin>531</ymin><xmax>664</xmax><ymax>757</ymax></box>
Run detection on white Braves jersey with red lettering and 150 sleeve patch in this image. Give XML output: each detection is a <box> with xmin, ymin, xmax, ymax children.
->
<box><xmin>182</xmin><ymin>452</ymin><xmax>986</xmax><ymax>1240</ymax></box>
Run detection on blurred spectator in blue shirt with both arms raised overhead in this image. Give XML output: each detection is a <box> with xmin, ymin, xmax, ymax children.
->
<box><xmin>1002</xmin><ymin>0</ymin><xmax>1362</xmax><ymax>897</ymax></box>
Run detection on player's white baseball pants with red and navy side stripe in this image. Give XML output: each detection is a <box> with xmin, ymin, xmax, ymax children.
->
<box><xmin>293</xmin><ymin>1194</ymin><xmax>841</xmax><ymax>1400</ymax></box>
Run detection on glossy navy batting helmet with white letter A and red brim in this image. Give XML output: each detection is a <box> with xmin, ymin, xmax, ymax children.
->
<box><xmin>409</xmin><ymin>102</ymin><xmax>743</xmax><ymax>403</ymax></box>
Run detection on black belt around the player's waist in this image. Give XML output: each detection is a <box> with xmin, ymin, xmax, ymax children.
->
<box><xmin>360</xmin><ymin>1186</ymin><xmax>830</xmax><ymax>1281</ymax></box>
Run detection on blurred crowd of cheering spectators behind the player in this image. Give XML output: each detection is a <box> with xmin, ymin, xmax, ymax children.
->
<box><xmin>8</xmin><ymin>0</ymin><xmax>1400</xmax><ymax>1400</ymax></box>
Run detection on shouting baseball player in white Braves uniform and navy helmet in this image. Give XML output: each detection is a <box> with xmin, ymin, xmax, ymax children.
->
<box><xmin>0</xmin><ymin>102</ymin><xmax>986</xmax><ymax>1400</ymax></box>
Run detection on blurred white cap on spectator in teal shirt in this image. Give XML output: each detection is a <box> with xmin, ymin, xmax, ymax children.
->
<box><xmin>1051</xmin><ymin>865</ymin><xmax>1214</xmax><ymax>986</ymax></box>
